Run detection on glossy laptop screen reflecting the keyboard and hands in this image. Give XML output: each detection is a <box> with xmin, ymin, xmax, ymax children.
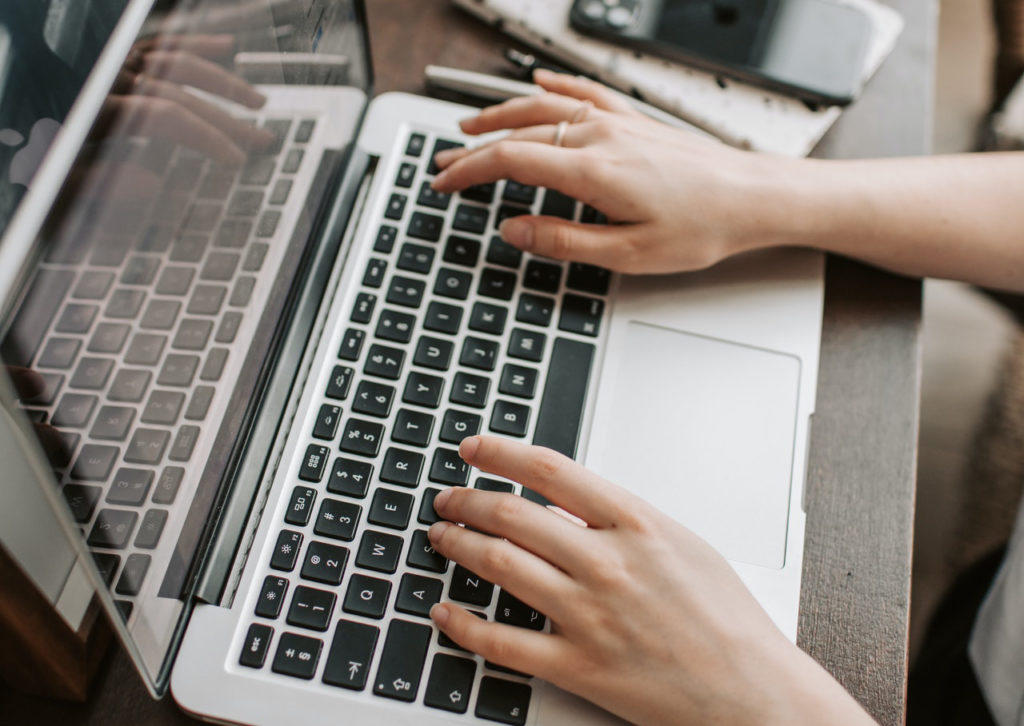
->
<box><xmin>0</xmin><ymin>0</ymin><xmax>371</xmax><ymax>693</ymax></box>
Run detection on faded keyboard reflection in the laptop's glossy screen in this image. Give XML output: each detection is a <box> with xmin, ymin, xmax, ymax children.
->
<box><xmin>9</xmin><ymin>113</ymin><xmax>315</xmax><ymax>620</ymax></box>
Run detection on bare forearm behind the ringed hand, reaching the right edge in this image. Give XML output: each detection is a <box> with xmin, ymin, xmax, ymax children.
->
<box><xmin>751</xmin><ymin>154</ymin><xmax>1024</xmax><ymax>292</ymax></box>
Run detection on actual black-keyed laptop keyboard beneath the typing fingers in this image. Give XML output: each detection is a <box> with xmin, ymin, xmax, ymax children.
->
<box><xmin>238</xmin><ymin>132</ymin><xmax>610</xmax><ymax>724</ymax></box>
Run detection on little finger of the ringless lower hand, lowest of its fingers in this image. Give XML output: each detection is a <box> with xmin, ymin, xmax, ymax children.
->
<box><xmin>430</xmin><ymin>602</ymin><xmax>568</xmax><ymax>681</ymax></box>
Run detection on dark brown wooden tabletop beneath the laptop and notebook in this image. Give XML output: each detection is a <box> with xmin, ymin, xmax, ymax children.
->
<box><xmin>0</xmin><ymin>0</ymin><xmax>936</xmax><ymax>726</ymax></box>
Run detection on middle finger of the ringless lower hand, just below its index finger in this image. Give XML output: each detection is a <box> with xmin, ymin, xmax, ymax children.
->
<box><xmin>434</xmin><ymin>487</ymin><xmax>592</xmax><ymax>574</ymax></box>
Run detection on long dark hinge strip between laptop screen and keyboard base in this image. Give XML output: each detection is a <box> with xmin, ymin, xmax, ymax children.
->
<box><xmin>196</xmin><ymin>148</ymin><xmax>377</xmax><ymax>606</ymax></box>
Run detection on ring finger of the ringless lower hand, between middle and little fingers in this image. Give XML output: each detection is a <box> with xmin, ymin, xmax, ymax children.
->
<box><xmin>427</xmin><ymin>522</ymin><xmax>575</xmax><ymax>620</ymax></box>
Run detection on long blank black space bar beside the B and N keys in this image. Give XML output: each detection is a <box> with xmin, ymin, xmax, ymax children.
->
<box><xmin>522</xmin><ymin>338</ymin><xmax>595</xmax><ymax>504</ymax></box>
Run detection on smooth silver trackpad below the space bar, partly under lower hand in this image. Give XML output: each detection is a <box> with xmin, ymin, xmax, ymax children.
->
<box><xmin>590</xmin><ymin>323</ymin><xmax>800</xmax><ymax>568</ymax></box>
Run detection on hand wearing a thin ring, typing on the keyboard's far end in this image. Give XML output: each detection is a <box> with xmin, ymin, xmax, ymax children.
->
<box><xmin>433</xmin><ymin>71</ymin><xmax>795</xmax><ymax>272</ymax></box>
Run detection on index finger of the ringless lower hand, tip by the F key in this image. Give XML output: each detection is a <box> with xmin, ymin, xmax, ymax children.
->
<box><xmin>459</xmin><ymin>436</ymin><xmax>634</xmax><ymax>528</ymax></box>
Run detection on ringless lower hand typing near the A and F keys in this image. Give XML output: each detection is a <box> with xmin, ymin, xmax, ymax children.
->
<box><xmin>429</xmin><ymin>436</ymin><xmax>872</xmax><ymax>726</ymax></box>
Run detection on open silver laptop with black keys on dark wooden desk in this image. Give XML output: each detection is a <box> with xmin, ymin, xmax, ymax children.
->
<box><xmin>0</xmin><ymin>0</ymin><xmax>823</xmax><ymax>726</ymax></box>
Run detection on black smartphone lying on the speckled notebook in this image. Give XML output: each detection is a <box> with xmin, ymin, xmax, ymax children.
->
<box><xmin>569</xmin><ymin>0</ymin><xmax>871</xmax><ymax>105</ymax></box>
